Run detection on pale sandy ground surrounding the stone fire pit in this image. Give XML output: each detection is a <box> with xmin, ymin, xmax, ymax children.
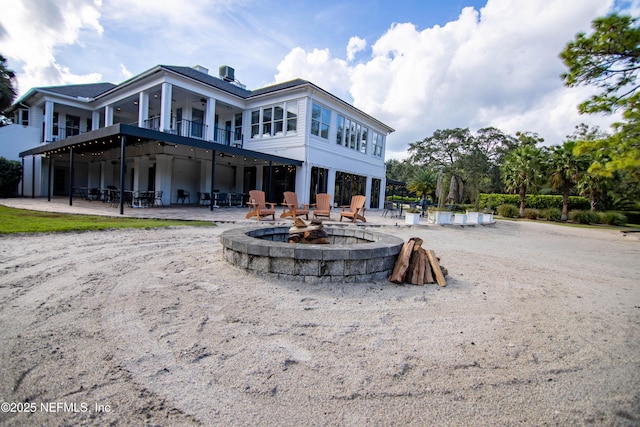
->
<box><xmin>0</xmin><ymin>221</ymin><xmax>640</xmax><ymax>426</ymax></box>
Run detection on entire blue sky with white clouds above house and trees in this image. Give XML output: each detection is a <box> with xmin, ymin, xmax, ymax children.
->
<box><xmin>0</xmin><ymin>0</ymin><xmax>640</xmax><ymax>158</ymax></box>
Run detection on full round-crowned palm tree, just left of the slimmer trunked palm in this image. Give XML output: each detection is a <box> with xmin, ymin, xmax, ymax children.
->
<box><xmin>502</xmin><ymin>144</ymin><xmax>543</xmax><ymax>217</ymax></box>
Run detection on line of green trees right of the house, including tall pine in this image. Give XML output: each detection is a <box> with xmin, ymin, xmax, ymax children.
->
<box><xmin>386</xmin><ymin>14</ymin><xmax>640</xmax><ymax>220</ymax></box>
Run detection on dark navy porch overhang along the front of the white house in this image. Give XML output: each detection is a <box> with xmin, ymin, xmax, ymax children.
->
<box><xmin>19</xmin><ymin>123</ymin><xmax>302</xmax><ymax>166</ymax></box>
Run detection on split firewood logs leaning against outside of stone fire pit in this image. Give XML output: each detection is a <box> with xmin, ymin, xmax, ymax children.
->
<box><xmin>389</xmin><ymin>237</ymin><xmax>447</xmax><ymax>286</ymax></box>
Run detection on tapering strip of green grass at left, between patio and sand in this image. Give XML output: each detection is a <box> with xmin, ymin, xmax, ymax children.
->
<box><xmin>0</xmin><ymin>206</ymin><xmax>215</xmax><ymax>234</ymax></box>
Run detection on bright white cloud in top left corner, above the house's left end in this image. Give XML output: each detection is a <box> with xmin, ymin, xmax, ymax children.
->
<box><xmin>0</xmin><ymin>0</ymin><xmax>103</xmax><ymax>93</ymax></box>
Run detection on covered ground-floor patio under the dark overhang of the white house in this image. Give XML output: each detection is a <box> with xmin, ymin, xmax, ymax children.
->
<box><xmin>20</xmin><ymin>124</ymin><xmax>302</xmax><ymax>215</ymax></box>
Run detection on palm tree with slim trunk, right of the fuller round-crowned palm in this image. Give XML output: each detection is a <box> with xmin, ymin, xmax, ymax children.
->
<box><xmin>549</xmin><ymin>140</ymin><xmax>589</xmax><ymax>221</ymax></box>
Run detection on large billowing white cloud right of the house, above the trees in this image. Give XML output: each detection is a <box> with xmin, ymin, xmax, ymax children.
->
<box><xmin>276</xmin><ymin>0</ymin><xmax>620</xmax><ymax>158</ymax></box>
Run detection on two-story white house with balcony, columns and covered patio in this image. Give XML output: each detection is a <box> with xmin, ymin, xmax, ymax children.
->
<box><xmin>5</xmin><ymin>65</ymin><xmax>393</xmax><ymax>212</ymax></box>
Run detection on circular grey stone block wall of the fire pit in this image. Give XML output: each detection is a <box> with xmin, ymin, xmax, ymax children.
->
<box><xmin>220</xmin><ymin>227</ymin><xmax>404</xmax><ymax>283</ymax></box>
